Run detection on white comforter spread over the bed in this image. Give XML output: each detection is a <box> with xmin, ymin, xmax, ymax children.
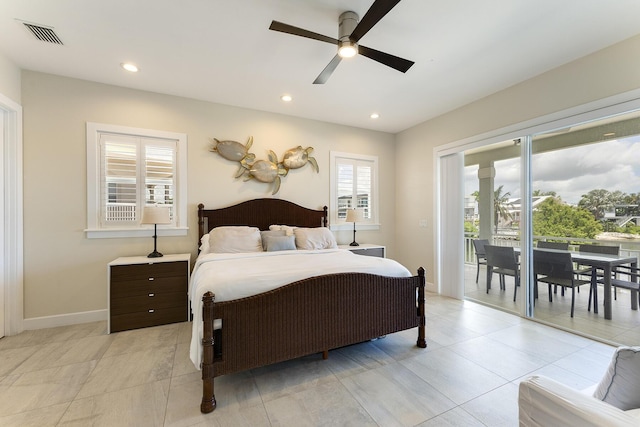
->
<box><xmin>189</xmin><ymin>249</ymin><xmax>411</xmax><ymax>369</ymax></box>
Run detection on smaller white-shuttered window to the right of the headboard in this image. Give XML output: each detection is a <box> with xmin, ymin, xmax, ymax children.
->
<box><xmin>330</xmin><ymin>151</ymin><xmax>379</xmax><ymax>229</ymax></box>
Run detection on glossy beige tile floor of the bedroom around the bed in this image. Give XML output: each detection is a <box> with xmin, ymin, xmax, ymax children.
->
<box><xmin>0</xmin><ymin>295</ymin><xmax>613</xmax><ymax>427</ymax></box>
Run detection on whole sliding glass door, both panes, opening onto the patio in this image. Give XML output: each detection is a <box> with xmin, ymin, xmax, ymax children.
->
<box><xmin>456</xmin><ymin>111</ymin><xmax>640</xmax><ymax>345</ymax></box>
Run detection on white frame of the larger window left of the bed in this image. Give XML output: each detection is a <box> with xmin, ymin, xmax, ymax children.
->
<box><xmin>85</xmin><ymin>122</ymin><xmax>189</xmax><ymax>239</ymax></box>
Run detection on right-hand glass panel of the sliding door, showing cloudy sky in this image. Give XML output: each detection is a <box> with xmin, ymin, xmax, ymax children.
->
<box><xmin>531</xmin><ymin>111</ymin><xmax>640</xmax><ymax>345</ymax></box>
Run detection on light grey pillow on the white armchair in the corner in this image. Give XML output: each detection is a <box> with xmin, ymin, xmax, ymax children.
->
<box><xmin>593</xmin><ymin>347</ymin><xmax>640</xmax><ymax>411</ymax></box>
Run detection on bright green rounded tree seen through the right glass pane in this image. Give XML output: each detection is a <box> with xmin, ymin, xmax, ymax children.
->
<box><xmin>533</xmin><ymin>198</ymin><xmax>602</xmax><ymax>239</ymax></box>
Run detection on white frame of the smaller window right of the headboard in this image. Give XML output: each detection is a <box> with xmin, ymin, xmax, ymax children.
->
<box><xmin>329</xmin><ymin>151</ymin><xmax>380</xmax><ymax>230</ymax></box>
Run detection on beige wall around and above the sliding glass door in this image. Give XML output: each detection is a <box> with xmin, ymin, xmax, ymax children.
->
<box><xmin>396</xmin><ymin>36</ymin><xmax>640</xmax><ymax>290</ymax></box>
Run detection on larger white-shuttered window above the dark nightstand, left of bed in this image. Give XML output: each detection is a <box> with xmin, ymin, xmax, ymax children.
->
<box><xmin>87</xmin><ymin>123</ymin><xmax>187</xmax><ymax>237</ymax></box>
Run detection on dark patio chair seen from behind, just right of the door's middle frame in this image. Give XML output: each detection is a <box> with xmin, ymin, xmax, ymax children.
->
<box><xmin>533</xmin><ymin>249</ymin><xmax>593</xmax><ymax>317</ymax></box>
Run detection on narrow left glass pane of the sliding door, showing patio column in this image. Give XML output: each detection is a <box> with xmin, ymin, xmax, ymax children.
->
<box><xmin>464</xmin><ymin>138</ymin><xmax>524</xmax><ymax>313</ymax></box>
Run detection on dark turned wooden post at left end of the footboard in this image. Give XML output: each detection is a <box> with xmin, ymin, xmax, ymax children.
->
<box><xmin>200</xmin><ymin>292</ymin><xmax>216</xmax><ymax>414</ymax></box>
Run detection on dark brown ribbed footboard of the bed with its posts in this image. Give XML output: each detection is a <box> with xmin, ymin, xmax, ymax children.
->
<box><xmin>200</xmin><ymin>268</ymin><xmax>427</xmax><ymax>413</ymax></box>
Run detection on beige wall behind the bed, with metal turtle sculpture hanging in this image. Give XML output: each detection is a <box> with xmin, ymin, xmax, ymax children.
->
<box><xmin>22</xmin><ymin>71</ymin><xmax>395</xmax><ymax>319</ymax></box>
